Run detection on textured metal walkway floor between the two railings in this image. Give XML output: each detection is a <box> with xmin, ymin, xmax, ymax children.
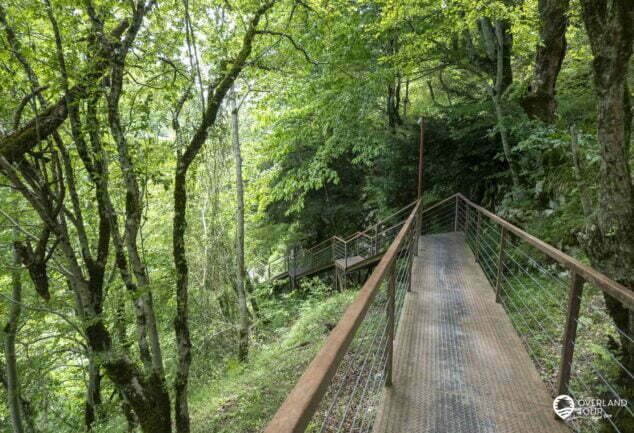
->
<box><xmin>374</xmin><ymin>233</ymin><xmax>570</xmax><ymax>433</ymax></box>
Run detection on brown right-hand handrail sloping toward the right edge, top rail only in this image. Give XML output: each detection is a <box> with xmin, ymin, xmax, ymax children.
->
<box><xmin>457</xmin><ymin>193</ymin><xmax>634</xmax><ymax>310</ymax></box>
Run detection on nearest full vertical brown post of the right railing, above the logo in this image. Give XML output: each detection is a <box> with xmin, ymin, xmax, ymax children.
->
<box><xmin>557</xmin><ymin>270</ymin><xmax>584</xmax><ymax>395</ymax></box>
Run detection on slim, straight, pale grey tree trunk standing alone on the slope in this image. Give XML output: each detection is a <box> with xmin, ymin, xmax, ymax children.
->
<box><xmin>230</xmin><ymin>88</ymin><xmax>249</xmax><ymax>361</ymax></box>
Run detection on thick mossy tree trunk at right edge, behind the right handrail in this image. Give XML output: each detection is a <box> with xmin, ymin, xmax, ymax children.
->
<box><xmin>581</xmin><ymin>0</ymin><xmax>634</xmax><ymax>398</ymax></box>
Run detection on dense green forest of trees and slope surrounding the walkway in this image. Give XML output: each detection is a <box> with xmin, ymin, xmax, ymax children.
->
<box><xmin>0</xmin><ymin>0</ymin><xmax>634</xmax><ymax>433</ymax></box>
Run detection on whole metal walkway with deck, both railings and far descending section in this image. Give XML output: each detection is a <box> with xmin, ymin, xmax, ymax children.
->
<box><xmin>256</xmin><ymin>194</ymin><xmax>634</xmax><ymax>433</ymax></box>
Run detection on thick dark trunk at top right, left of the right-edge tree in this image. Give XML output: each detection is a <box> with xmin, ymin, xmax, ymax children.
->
<box><xmin>522</xmin><ymin>0</ymin><xmax>570</xmax><ymax>123</ymax></box>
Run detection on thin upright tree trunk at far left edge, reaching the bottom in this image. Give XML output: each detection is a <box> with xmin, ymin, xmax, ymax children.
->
<box><xmin>4</xmin><ymin>233</ymin><xmax>24</xmax><ymax>433</ymax></box>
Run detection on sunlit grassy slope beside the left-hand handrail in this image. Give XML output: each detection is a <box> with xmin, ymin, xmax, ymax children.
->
<box><xmin>190</xmin><ymin>280</ymin><xmax>355</xmax><ymax>433</ymax></box>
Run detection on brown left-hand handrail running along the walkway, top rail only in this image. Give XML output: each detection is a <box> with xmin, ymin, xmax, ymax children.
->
<box><xmin>264</xmin><ymin>201</ymin><xmax>420</xmax><ymax>433</ymax></box>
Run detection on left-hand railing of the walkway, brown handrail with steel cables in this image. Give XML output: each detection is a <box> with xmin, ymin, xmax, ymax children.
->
<box><xmin>265</xmin><ymin>204</ymin><xmax>420</xmax><ymax>433</ymax></box>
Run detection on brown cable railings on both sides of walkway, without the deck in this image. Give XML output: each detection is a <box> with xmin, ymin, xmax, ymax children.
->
<box><xmin>266</xmin><ymin>194</ymin><xmax>634</xmax><ymax>433</ymax></box>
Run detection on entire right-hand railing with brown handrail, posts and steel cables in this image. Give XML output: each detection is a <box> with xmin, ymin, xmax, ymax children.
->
<box><xmin>455</xmin><ymin>196</ymin><xmax>634</xmax><ymax>433</ymax></box>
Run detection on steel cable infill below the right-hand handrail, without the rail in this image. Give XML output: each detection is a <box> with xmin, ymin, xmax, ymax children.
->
<box><xmin>456</xmin><ymin>201</ymin><xmax>634</xmax><ymax>433</ymax></box>
